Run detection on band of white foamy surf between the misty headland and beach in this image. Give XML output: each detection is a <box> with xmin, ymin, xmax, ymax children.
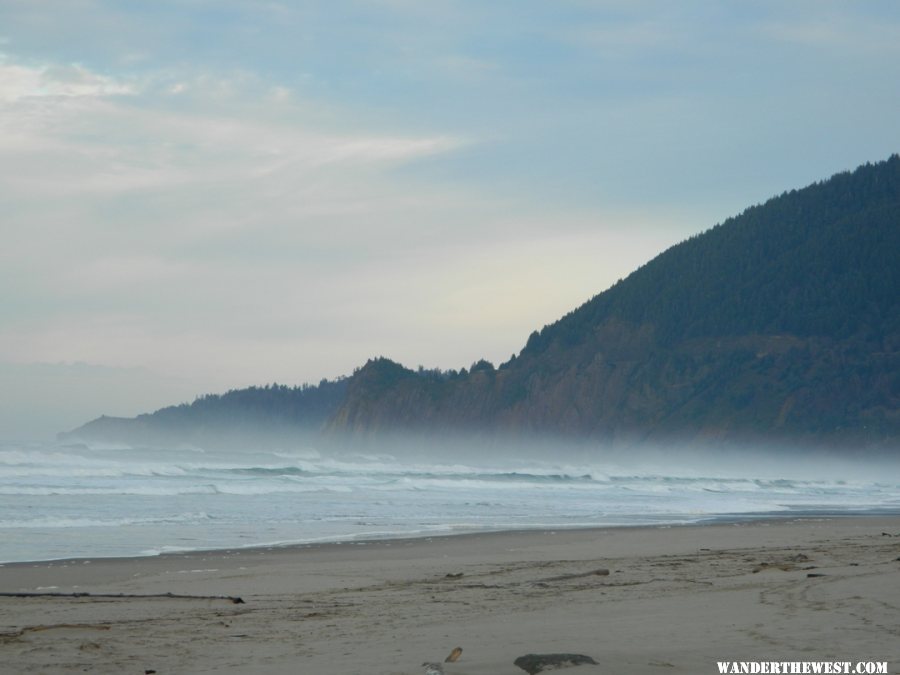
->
<box><xmin>0</xmin><ymin>443</ymin><xmax>900</xmax><ymax>563</ymax></box>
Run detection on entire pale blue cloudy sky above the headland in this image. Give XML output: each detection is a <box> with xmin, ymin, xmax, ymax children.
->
<box><xmin>0</xmin><ymin>0</ymin><xmax>900</xmax><ymax>438</ymax></box>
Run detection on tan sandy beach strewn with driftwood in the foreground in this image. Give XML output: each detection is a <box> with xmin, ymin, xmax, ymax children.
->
<box><xmin>0</xmin><ymin>517</ymin><xmax>900</xmax><ymax>675</ymax></box>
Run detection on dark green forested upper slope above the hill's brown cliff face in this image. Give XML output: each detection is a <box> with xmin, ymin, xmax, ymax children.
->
<box><xmin>526</xmin><ymin>155</ymin><xmax>900</xmax><ymax>353</ymax></box>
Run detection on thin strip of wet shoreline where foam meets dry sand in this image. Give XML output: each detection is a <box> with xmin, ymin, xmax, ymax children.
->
<box><xmin>0</xmin><ymin>509</ymin><xmax>900</xmax><ymax>570</ymax></box>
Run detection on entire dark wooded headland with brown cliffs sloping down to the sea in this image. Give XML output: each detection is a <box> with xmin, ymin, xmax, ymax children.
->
<box><xmin>65</xmin><ymin>155</ymin><xmax>900</xmax><ymax>447</ymax></box>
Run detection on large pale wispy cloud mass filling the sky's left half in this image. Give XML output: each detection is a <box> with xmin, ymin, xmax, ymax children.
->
<box><xmin>0</xmin><ymin>52</ymin><xmax>486</xmax><ymax>388</ymax></box>
